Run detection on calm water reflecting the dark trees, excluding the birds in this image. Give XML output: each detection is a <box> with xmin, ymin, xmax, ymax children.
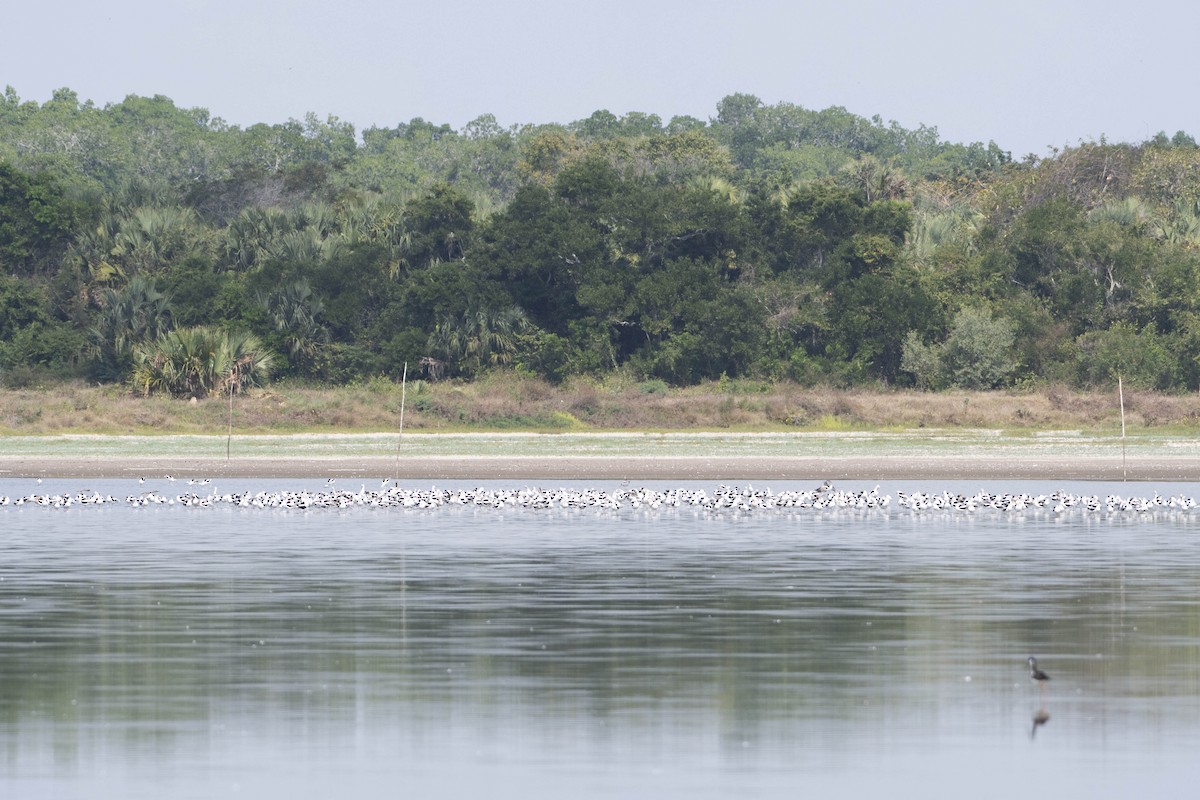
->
<box><xmin>0</xmin><ymin>480</ymin><xmax>1200</xmax><ymax>800</ymax></box>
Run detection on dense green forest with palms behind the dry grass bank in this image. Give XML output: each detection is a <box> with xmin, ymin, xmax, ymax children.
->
<box><xmin>0</xmin><ymin>88</ymin><xmax>1200</xmax><ymax>396</ymax></box>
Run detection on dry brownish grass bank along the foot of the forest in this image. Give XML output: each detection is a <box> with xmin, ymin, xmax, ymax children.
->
<box><xmin>0</xmin><ymin>374</ymin><xmax>1200</xmax><ymax>434</ymax></box>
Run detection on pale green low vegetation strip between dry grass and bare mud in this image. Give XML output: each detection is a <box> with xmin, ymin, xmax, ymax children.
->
<box><xmin>0</xmin><ymin>428</ymin><xmax>1200</xmax><ymax>465</ymax></box>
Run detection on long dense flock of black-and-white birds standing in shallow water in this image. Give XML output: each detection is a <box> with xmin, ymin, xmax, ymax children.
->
<box><xmin>0</xmin><ymin>479</ymin><xmax>1196</xmax><ymax>515</ymax></box>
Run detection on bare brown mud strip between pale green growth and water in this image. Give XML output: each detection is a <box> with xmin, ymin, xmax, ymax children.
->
<box><xmin>0</xmin><ymin>452</ymin><xmax>1200</xmax><ymax>482</ymax></box>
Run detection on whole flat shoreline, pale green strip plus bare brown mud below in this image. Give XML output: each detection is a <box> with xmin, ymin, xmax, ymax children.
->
<box><xmin>0</xmin><ymin>429</ymin><xmax>1200</xmax><ymax>482</ymax></box>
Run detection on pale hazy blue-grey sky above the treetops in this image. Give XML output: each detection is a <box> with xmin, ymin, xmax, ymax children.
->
<box><xmin>0</xmin><ymin>0</ymin><xmax>1200</xmax><ymax>158</ymax></box>
